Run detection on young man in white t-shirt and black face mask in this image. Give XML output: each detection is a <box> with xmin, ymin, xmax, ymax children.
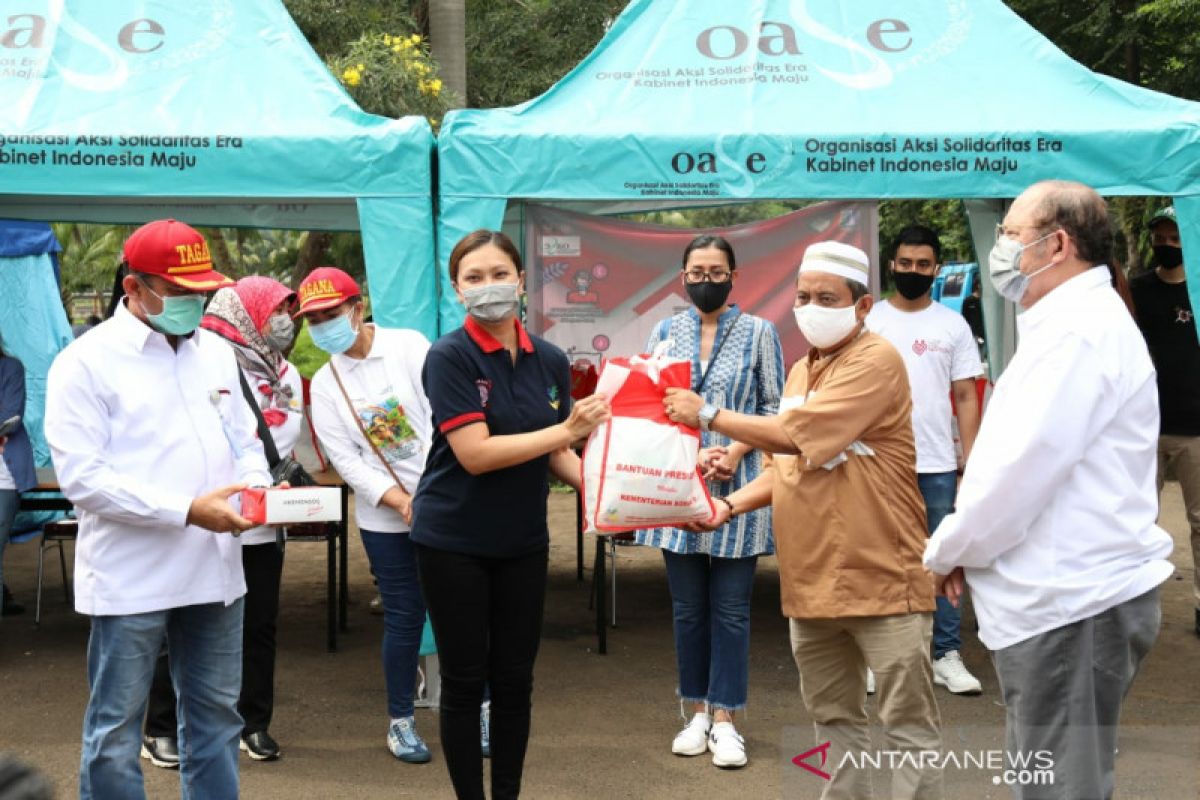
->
<box><xmin>866</xmin><ymin>225</ymin><xmax>983</xmax><ymax>694</ymax></box>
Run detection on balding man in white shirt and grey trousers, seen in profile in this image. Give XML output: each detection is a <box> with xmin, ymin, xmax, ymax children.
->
<box><xmin>925</xmin><ymin>181</ymin><xmax>1172</xmax><ymax>798</ymax></box>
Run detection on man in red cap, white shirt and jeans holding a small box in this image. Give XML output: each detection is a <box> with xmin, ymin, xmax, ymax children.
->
<box><xmin>46</xmin><ymin>219</ymin><xmax>271</xmax><ymax>799</ymax></box>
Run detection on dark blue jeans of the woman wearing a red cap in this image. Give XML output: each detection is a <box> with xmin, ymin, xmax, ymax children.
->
<box><xmin>360</xmin><ymin>530</ymin><xmax>425</xmax><ymax>720</ymax></box>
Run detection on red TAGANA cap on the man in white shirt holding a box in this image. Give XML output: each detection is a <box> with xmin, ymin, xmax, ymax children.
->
<box><xmin>125</xmin><ymin>219</ymin><xmax>233</xmax><ymax>291</ymax></box>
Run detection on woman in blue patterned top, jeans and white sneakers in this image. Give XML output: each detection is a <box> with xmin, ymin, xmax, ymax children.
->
<box><xmin>637</xmin><ymin>235</ymin><xmax>784</xmax><ymax>769</ymax></box>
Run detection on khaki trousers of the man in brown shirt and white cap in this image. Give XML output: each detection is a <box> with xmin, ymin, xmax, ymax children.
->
<box><xmin>791</xmin><ymin>613</ymin><xmax>942</xmax><ymax>800</ymax></box>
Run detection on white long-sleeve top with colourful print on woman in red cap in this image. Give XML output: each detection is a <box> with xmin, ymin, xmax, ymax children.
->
<box><xmin>312</xmin><ymin>325</ymin><xmax>433</xmax><ymax>533</ymax></box>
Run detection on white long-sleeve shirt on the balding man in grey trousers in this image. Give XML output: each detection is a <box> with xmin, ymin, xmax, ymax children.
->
<box><xmin>925</xmin><ymin>266</ymin><xmax>1172</xmax><ymax>650</ymax></box>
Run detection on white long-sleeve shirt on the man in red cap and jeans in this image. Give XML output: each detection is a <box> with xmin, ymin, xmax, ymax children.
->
<box><xmin>46</xmin><ymin>305</ymin><xmax>270</xmax><ymax>615</ymax></box>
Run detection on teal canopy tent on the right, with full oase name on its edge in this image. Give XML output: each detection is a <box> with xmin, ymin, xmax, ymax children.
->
<box><xmin>438</xmin><ymin>0</ymin><xmax>1200</xmax><ymax>366</ymax></box>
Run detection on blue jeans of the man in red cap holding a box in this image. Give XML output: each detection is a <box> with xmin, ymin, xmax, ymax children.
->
<box><xmin>79</xmin><ymin>599</ymin><xmax>242</xmax><ymax>800</ymax></box>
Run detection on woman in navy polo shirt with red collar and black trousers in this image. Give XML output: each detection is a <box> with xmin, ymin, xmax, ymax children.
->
<box><xmin>412</xmin><ymin>230</ymin><xmax>608</xmax><ymax>800</ymax></box>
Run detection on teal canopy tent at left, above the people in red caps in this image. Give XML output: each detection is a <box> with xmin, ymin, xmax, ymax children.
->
<box><xmin>0</xmin><ymin>0</ymin><xmax>438</xmax><ymax>335</ymax></box>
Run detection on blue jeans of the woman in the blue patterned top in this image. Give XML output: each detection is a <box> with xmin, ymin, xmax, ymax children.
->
<box><xmin>662</xmin><ymin>551</ymin><xmax>758</xmax><ymax>711</ymax></box>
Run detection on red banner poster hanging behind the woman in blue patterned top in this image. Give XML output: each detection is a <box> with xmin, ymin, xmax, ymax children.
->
<box><xmin>526</xmin><ymin>201</ymin><xmax>878</xmax><ymax>376</ymax></box>
